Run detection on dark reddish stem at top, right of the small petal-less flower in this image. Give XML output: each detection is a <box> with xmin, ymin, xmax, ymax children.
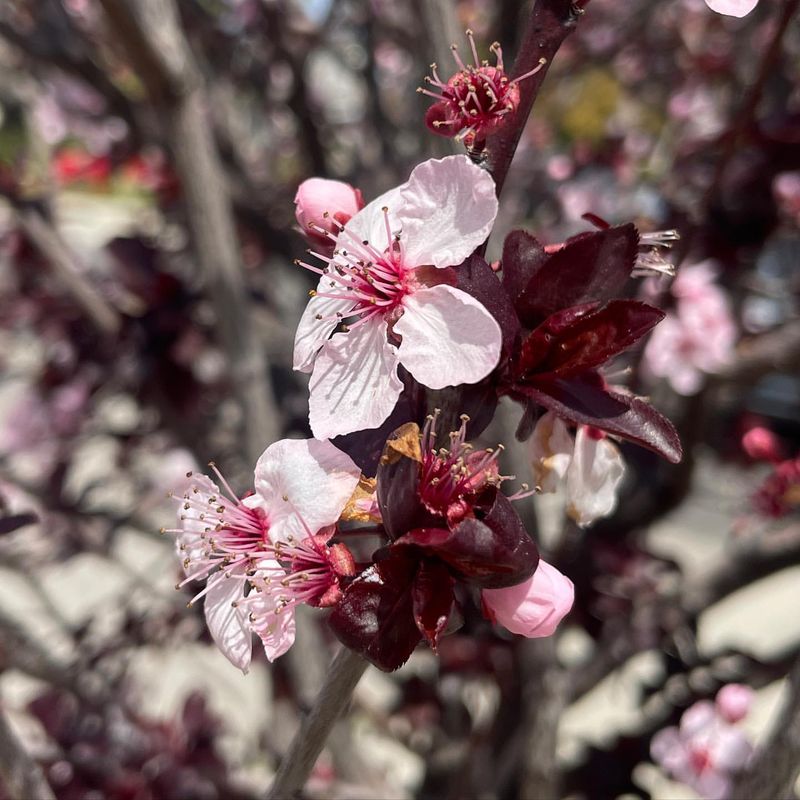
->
<box><xmin>489</xmin><ymin>0</ymin><xmax>585</xmax><ymax>197</ymax></box>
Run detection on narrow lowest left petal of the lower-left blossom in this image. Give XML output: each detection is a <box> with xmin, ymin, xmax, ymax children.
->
<box><xmin>203</xmin><ymin>571</ymin><xmax>253</xmax><ymax>674</ymax></box>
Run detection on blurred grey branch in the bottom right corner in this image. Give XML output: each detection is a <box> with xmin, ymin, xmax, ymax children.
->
<box><xmin>731</xmin><ymin>659</ymin><xmax>800</xmax><ymax>800</ymax></box>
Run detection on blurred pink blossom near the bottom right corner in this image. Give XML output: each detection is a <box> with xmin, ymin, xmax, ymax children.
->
<box><xmin>650</xmin><ymin>687</ymin><xmax>753</xmax><ymax>800</ymax></box>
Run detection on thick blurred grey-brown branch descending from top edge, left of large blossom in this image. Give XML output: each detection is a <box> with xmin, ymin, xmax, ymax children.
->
<box><xmin>101</xmin><ymin>0</ymin><xmax>281</xmax><ymax>461</ymax></box>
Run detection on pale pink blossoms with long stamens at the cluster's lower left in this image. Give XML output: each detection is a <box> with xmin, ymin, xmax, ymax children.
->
<box><xmin>166</xmin><ymin>439</ymin><xmax>360</xmax><ymax>672</ymax></box>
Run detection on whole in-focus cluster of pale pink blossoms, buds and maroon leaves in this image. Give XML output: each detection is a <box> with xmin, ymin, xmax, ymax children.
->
<box><xmin>166</xmin><ymin>32</ymin><xmax>688</xmax><ymax>670</ymax></box>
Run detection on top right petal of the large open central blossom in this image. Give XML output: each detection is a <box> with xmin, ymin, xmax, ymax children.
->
<box><xmin>401</xmin><ymin>155</ymin><xmax>497</xmax><ymax>267</ymax></box>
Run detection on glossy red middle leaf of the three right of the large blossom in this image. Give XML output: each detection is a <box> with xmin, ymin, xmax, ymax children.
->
<box><xmin>520</xmin><ymin>300</ymin><xmax>664</xmax><ymax>378</ymax></box>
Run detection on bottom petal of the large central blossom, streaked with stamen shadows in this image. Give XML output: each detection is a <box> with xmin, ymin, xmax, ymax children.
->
<box><xmin>308</xmin><ymin>320</ymin><xmax>403</xmax><ymax>439</ymax></box>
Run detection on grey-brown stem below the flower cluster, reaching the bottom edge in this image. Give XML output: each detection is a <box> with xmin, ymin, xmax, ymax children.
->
<box><xmin>266</xmin><ymin>647</ymin><xmax>368</xmax><ymax>800</ymax></box>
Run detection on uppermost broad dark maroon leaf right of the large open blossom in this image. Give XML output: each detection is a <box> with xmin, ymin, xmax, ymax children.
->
<box><xmin>512</xmin><ymin>223</ymin><xmax>639</xmax><ymax>328</ymax></box>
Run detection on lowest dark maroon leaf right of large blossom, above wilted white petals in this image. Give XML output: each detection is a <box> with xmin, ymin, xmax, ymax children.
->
<box><xmin>516</xmin><ymin>373</ymin><xmax>683</xmax><ymax>464</ymax></box>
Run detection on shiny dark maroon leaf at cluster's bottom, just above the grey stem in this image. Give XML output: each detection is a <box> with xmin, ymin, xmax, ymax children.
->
<box><xmin>328</xmin><ymin>552</ymin><xmax>422</xmax><ymax>672</ymax></box>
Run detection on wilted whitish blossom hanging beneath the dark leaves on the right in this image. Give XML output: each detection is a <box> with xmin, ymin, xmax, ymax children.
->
<box><xmin>529</xmin><ymin>411</ymin><xmax>625</xmax><ymax>527</ymax></box>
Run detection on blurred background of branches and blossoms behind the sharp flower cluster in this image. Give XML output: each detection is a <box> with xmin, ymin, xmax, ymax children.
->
<box><xmin>0</xmin><ymin>0</ymin><xmax>800</xmax><ymax>800</ymax></box>
